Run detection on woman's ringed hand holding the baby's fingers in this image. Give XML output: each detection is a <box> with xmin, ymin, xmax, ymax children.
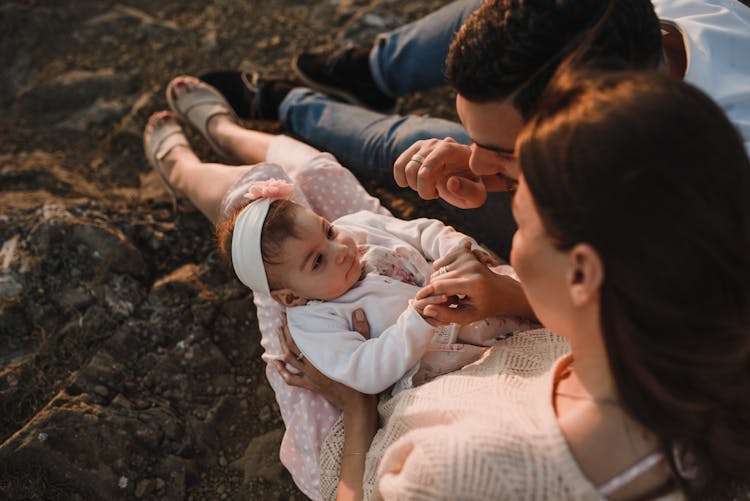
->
<box><xmin>416</xmin><ymin>246</ymin><xmax>534</xmax><ymax>325</ymax></box>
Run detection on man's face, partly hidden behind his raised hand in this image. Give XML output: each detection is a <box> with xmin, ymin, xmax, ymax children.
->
<box><xmin>456</xmin><ymin>95</ymin><xmax>523</xmax><ymax>191</ymax></box>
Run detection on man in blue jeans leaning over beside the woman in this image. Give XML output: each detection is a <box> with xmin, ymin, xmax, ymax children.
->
<box><xmin>208</xmin><ymin>0</ymin><xmax>750</xmax><ymax>256</ymax></box>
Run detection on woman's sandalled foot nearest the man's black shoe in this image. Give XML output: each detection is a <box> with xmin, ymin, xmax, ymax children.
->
<box><xmin>167</xmin><ymin>75</ymin><xmax>241</xmax><ymax>163</ymax></box>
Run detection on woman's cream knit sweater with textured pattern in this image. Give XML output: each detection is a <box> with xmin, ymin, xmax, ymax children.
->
<box><xmin>321</xmin><ymin>329</ymin><xmax>680</xmax><ymax>500</ymax></box>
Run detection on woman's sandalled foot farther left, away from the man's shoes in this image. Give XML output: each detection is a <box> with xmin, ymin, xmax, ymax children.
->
<box><xmin>143</xmin><ymin>111</ymin><xmax>200</xmax><ymax>209</ymax></box>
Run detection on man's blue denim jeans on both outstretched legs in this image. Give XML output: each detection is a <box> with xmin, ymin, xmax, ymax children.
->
<box><xmin>279</xmin><ymin>0</ymin><xmax>516</xmax><ymax>259</ymax></box>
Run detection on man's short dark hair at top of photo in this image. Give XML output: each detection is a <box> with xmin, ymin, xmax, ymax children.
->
<box><xmin>446</xmin><ymin>0</ymin><xmax>662</xmax><ymax>120</ymax></box>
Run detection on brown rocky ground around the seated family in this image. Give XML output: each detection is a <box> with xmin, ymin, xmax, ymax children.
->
<box><xmin>0</xmin><ymin>0</ymin><xmax>452</xmax><ymax>500</ymax></box>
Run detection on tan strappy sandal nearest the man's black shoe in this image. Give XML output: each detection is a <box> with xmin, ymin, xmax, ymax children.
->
<box><xmin>167</xmin><ymin>75</ymin><xmax>239</xmax><ymax>164</ymax></box>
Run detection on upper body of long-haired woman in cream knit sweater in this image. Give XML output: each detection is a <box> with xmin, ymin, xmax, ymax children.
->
<box><xmin>278</xmin><ymin>73</ymin><xmax>750</xmax><ymax>499</ymax></box>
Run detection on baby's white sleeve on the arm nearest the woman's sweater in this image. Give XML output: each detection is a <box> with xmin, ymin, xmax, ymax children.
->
<box><xmin>288</xmin><ymin>304</ymin><xmax>434</xmax><ymax>394</ymax></box>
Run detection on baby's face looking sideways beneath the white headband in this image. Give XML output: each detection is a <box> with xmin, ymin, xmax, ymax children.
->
<box><xmin>268</xmin><ymin>207</ymin><xmax>362</xmax><ymax>300</ymax></box>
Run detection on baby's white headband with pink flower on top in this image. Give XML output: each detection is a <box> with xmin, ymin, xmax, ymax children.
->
<box><xmin>232</xmin><ymin>180</ymin><xmax>294</xmax><ymax>296</ymax></box>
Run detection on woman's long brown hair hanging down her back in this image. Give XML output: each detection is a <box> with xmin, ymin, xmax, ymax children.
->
<box><xmin>517</xmin><ymin>71</ymin><xmax>750</xmax><ymax>499</ymax></box>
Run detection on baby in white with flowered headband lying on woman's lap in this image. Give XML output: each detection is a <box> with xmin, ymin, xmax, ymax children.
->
<box><xmin>219</xmin><ymin>179</ymin><xmax>532</xmax><ymax>394</ymax></box>
